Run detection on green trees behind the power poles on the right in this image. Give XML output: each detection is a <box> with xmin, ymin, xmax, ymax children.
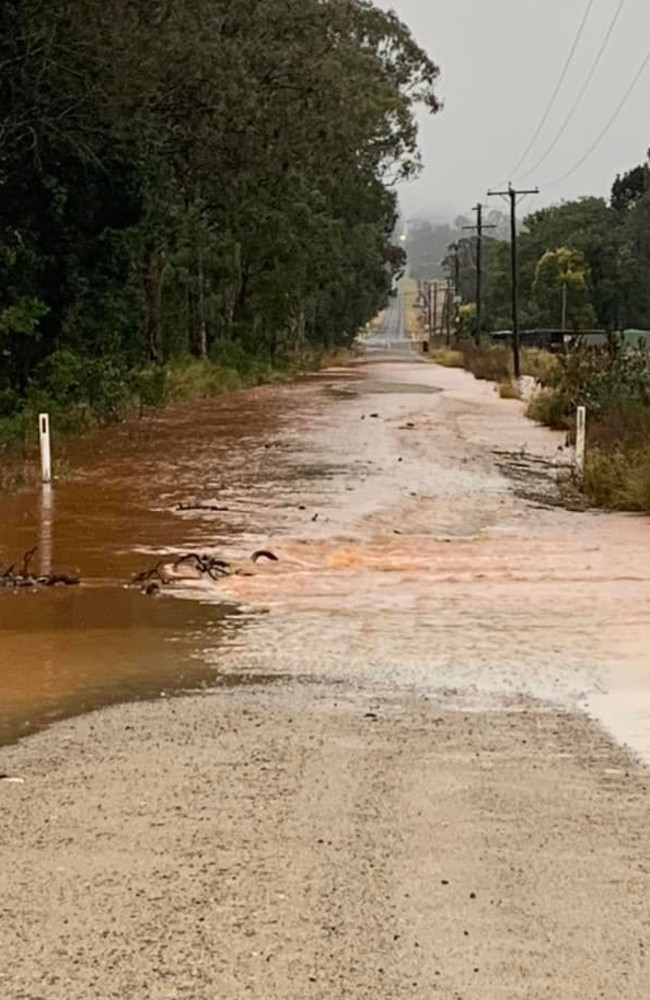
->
<box><xmin>408</xmin><ymin>163</ymin><xmax>650</xmax><ymax>331</ymax></box>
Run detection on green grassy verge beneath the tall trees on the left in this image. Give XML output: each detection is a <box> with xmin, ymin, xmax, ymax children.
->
<box><xmin>0</xmin><ymin>350</ymin><xmax>351</xmax><ymax>492</ymax></box>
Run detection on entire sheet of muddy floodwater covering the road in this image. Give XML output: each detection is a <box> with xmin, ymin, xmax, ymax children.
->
<box><xmin>0</xmin><ymin>312</ymin><xmax>650</xmax><ymax>758</ymax></box>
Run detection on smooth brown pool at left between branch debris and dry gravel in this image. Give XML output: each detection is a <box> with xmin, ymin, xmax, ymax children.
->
<box><xmin>0</xmin><ymin>587</ymin><xmax>238</xmax><ymax>743</ymax></box>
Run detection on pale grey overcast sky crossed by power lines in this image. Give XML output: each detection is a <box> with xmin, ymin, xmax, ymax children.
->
<box><xmin>379</xmin><ymin>0</ymin><xmax>650</xmax><ymax>218</ymax></box>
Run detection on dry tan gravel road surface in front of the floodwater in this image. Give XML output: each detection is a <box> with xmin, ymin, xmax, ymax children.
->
<box><xmin>0</xmin><ymin>682</ymin><xmax>650</xmax><ymax>1000</ymax></box>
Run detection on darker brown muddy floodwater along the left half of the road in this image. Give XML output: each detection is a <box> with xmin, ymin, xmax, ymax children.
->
<box><xmin>0</xmin><ymin>378</ymin><xmax>319</xmax><ymax>743</ymax></box>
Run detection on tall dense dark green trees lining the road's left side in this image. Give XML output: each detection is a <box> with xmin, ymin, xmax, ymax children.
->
<box><xmin>0</xmin><ymin>0</ymin><xmax>438</xmax><ymax>414</ymax></box>
